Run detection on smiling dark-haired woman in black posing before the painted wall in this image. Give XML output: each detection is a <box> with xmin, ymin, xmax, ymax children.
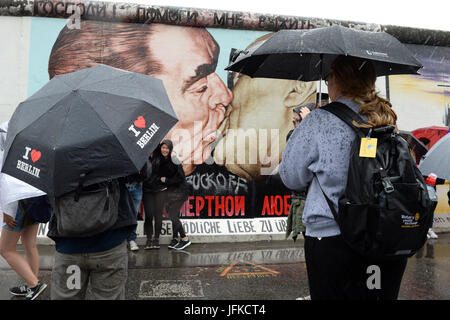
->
<box><xmin>143</xmin><ymin>140</ymin><xmax>191</xmax><ymax>250</ymax></box>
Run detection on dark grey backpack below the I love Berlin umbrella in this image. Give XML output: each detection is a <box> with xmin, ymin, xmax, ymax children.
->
<box><xmin>50</xmin><ymin>175</ymin><xmax>120</xmax><ymax>238</ymax></box>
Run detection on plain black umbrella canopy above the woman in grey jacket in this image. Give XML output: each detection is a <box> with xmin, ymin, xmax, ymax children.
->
<box><xmin>226</xmin><ymin>26</ymin><xmax>422</xmax><ymax>81</ymax></box>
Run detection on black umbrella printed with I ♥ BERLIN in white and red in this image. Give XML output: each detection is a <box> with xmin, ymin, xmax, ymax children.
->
<box><xmin>2</xmin><ymin>65</ymin><xmax>178</xmax><ymax>196</ymax></box>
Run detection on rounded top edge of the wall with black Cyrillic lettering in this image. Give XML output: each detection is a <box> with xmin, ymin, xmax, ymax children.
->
<box><xmin>0</xmin><ymin>0</ymin><xmax>450</xmax><ymax>46</ymax></box>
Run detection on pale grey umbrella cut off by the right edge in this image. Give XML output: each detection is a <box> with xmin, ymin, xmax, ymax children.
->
<box><xmin>419</xmin><ymin>134</ymin><xmax>450</xmax><ymax>180</ymax></box>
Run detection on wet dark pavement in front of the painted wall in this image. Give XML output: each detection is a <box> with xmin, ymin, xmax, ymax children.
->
<box><xmin>0</xmin><ymin>233</ymin><xmax>450</xmax><ymax>300</ymax></box>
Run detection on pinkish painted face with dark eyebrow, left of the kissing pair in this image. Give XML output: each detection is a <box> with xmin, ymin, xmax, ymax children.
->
<box><xmin>150</xmin><ymin>24</ymin><xmax>232</xmax><ymax>175</ymax></box>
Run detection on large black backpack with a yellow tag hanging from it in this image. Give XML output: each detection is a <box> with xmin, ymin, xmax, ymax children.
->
<box><xmin>319</xmin><ymin>102</ymin><xmax>434</xmax><ymax>260</ymax></box>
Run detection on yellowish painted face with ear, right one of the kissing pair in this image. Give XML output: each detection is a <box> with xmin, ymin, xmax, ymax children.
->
<box><xmin>214</xmin><ymin>75</ymin><xmax>316</xmax><ymax>180</ymax></box>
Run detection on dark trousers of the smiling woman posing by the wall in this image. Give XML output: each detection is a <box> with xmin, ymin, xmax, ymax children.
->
<box><xmin>143</xmin><ymin>188</ymin><xmax>186</xmax><ymax>239</ymax></box>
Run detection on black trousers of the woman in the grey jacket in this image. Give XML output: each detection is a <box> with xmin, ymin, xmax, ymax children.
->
<box><xmin>305</xmin><ymin>236</ymin><xmax>407</xmax><ymax>300</ymax></box>
